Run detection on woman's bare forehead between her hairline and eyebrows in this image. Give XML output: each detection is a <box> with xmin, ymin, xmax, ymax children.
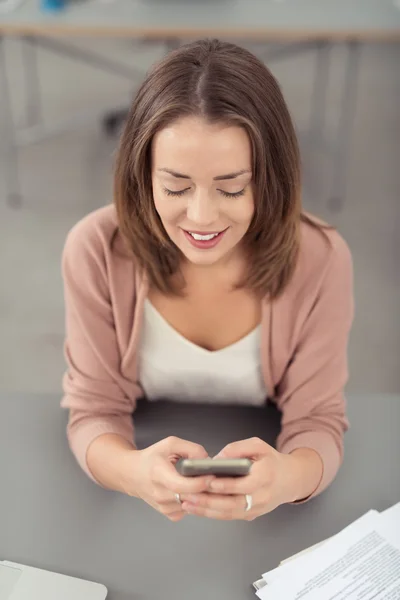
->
<box><xmin>152</xmin><ymin>117</ymin><xmax>251</xmax><ymax>177</ymax></box>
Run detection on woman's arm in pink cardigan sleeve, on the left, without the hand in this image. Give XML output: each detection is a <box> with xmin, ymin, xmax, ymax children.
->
<box><xmin>62</xmin><ymin>215</ymin><xmax>139</xmax><ymax>483</ymax></box>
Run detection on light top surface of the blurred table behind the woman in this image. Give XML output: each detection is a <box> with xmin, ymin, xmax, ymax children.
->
<box><xmin>0</xmin><ymin>0</ymin><xmax>400</xmax><ymax>40</ymax></box>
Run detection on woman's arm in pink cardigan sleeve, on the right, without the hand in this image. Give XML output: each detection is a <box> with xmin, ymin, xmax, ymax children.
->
<box><xmin>276</xmin><ymin>236</ymin><xmax>353</xmax><ymax>496</ymax></box>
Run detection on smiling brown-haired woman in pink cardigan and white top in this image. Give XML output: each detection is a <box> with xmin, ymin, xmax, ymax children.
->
<box><xmin>63</xmin><ymin>40</ymin><xmax>353</xmax><ymax>521</ymax></box>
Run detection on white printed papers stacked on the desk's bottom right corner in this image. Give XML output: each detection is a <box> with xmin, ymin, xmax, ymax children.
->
<box><xmin>257</xmin><ymin>504</ymin><xmax>400</xmax><ymax>600</ymax></box>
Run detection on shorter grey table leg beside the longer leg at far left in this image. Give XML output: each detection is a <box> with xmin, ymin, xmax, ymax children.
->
<box><xmin>22</xmin><ymin>36</ymin><xmax>43</xmax><ymax>127</ymax></box>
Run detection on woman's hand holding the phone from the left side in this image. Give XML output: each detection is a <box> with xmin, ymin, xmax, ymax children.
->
<box><xmin>123</xmin><ymin>437</ymin><xmax>214</xmax><ymax>521</ymax></box>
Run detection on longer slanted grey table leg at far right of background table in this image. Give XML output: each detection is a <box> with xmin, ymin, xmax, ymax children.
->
<box><xmin>328</xmin><ymin>40</ymin><xmax>360</xmax><ymax>212</ymax></box>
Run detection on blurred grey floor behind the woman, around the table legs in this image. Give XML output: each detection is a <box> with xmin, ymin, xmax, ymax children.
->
<box><xmin>0</xmin><ymin>40</ymin><xmax>400</xmax><ymax>392</ymax></box>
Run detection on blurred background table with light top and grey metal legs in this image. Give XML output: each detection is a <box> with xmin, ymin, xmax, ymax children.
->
<box><xmin>0</xmin><ymin>0</ymin><xmax>400</xmax><ymax>210</ymax></box>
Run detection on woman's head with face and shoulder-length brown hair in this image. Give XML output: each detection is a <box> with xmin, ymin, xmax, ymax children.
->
<box><xmin>115</xmin><ymin>40</ymin><xmax>302</xmax><ymax>297</ymax></box>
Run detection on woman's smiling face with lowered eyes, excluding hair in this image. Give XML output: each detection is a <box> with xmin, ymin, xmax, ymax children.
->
<box><xmin>152</xmin><ymin>117</ymin><xmax>254</xmax><ymax>265</ymax></box>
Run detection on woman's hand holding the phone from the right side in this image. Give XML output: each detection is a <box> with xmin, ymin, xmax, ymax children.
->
<box><xmin>182</xmin><ymin>438</ymin><xmax>323</xmax><ymax>521</ymax></box>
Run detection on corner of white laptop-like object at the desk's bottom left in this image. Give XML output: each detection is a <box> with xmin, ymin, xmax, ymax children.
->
<box><xmin>0</xmin><ymin>560</ymin><xmax>107</xmax><ymax>600</ymax></box>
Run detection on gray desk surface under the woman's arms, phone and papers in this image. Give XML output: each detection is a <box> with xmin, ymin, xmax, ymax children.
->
<box><xmin>0</xmin><ymin>394</ymin><xmax>400</xmax><ymax>600</ymax></box>
